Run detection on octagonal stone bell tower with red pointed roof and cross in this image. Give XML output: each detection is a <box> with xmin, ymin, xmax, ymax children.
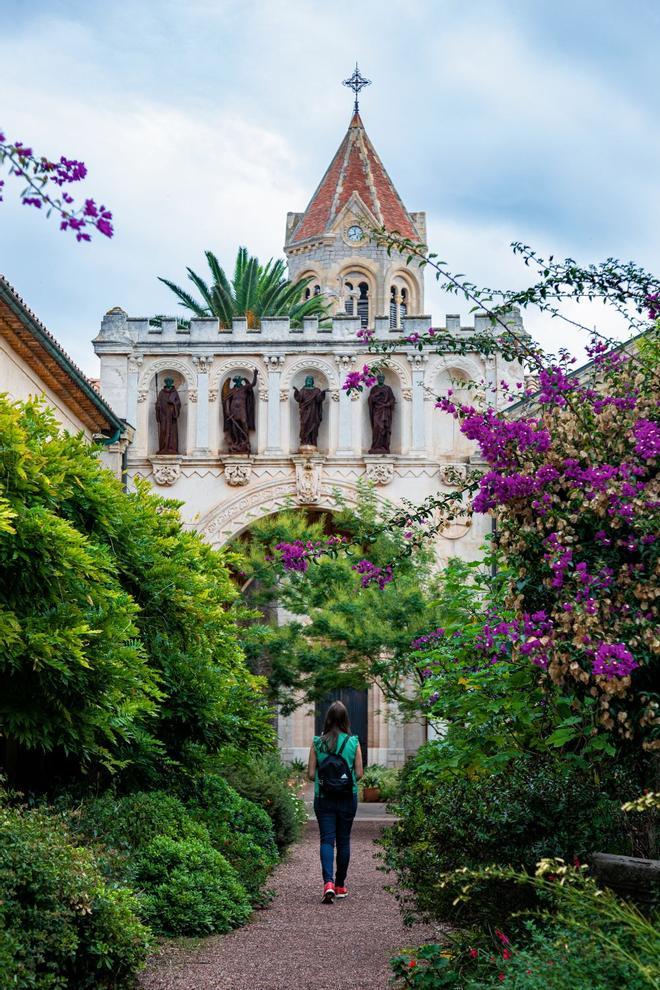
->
<box><xmin>284</xmin><ymin>65</ymin><xmax>426</xmax><ymax>329</ymax></box>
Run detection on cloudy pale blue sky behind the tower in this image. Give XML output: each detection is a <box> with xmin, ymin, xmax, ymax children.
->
<box><xmin>0</xmin><ymin>0</ymin><xmax>660</xmax><ymax>374</ymax></box>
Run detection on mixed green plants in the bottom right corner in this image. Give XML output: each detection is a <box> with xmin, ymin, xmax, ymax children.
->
<box><xmin>392</xmin><ymin>860</ymin><xmax>660</xmax><ymax>990</ymax></box>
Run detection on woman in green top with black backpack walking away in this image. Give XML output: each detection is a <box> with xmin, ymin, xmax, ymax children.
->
<box><xmin>307</xmin><ymin>701</ymin><xmax>362</xmax><ymax>904</ymax></box>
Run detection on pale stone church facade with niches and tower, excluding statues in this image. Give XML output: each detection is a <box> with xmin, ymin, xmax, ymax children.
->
<box><xmin>94</xmin><ymin>115</ymin><xmax>520</xmax><ymax>765</ymax></box>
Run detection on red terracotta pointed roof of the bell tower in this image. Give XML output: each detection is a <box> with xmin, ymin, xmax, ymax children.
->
<box><xmin>289</xmin><ymin>113</ymin><xmax>419</xmax><ymax>244</ymax></box>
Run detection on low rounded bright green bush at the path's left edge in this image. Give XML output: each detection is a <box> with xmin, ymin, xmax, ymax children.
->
<box><xmin>135</xmin><ymin>835</ymin><xmax>251</xmax><ymax>935</ymax></box>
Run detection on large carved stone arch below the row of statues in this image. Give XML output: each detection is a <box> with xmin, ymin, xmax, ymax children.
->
<box><xmin>197</xmin><ymin>478</ymin><xmax>385</xmax><ymax>548</ymax></box>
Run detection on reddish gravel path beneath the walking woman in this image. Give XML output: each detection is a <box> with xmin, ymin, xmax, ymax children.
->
<box><xmin>141</xmin><ymin>818</ymin><xmax>433</xmax><ymax>990</ymax></box>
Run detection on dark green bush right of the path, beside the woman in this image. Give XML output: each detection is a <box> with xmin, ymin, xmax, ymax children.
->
<box><xmin>381</xmin><ymin>742</ymin><xmax>634</xmax><ymax>922</ymax></box>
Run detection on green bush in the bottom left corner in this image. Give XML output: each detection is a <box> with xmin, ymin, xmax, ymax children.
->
<box><xmin>0</xmin><ymin>808</ymin><xmax>149</xmax><ymax>990</ymax></box>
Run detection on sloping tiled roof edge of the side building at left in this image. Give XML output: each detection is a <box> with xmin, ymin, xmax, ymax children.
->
<box><xmin>0</xmin><ymin>275</ymin><xmax>126</xmax><ymax>435</ymax></box>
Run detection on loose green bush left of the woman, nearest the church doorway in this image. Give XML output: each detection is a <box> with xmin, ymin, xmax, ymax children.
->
<box><xmin>214</xmin><ymin>747</ymin><xmax>307</xmax><ymax>852</ymax></box>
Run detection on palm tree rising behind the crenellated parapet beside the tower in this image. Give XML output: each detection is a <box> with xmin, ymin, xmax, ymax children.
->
<box><xmin>155</xmin><ymin>247</ymin><xmax>328</xmax><ymax>329</ymax></box>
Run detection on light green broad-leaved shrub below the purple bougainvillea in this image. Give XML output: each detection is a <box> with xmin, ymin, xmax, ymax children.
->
<box><xmin>412</xmin><ymin>550</ymin><xmax>556</xmax><ymax>777</ymax></box>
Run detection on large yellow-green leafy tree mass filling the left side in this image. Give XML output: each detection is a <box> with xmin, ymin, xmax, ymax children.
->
<box><xmin>0</xmin><ymin>398</ymin><xmax>273</xmax><ymax>786</ymax></box>
